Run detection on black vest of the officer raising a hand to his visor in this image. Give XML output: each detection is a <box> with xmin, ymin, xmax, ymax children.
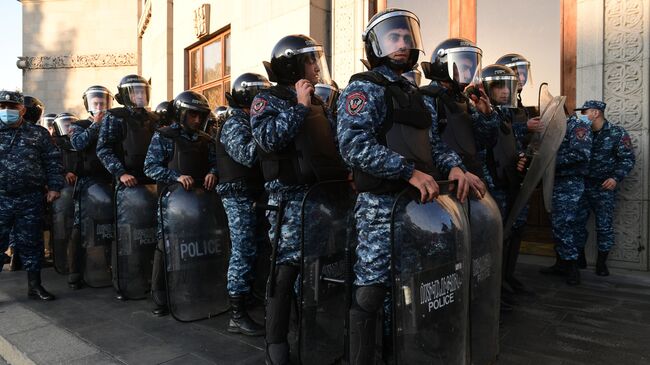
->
<box><xmin>257</xmin><ymin>86</ymin><xmax>347</xmax><ymax>185</ymax></box>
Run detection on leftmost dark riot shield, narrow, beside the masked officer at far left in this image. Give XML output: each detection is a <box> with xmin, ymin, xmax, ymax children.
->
<box><xmin>50</xmin><ymin>185</ymin><xmax>74</xmax><ymax>274</ymax></box>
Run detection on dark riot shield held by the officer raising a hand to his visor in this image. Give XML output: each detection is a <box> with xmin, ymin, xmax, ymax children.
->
<box><xmin>298</xmin><ymin>181</ymin><xmax>355</xmax><ymax>364</ymax></box>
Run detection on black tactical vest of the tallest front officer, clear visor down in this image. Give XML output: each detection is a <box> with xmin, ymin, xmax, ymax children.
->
<box><xmin>350</xmin><ymin>71</ymin><xmax>440</xmax><ymax>194</ymax></box>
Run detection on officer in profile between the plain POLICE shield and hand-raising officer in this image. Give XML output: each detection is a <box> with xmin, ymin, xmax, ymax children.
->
<box><xmin>217</xmin><ymin>73</ymin><xmax>271</xmax><ymax>336</ymax></box>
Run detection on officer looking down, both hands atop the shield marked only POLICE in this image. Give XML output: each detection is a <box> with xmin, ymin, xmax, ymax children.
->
<box><xmin>144</xmin><ymin>91</ymin><xmax>217</xmax><ymax>316</ymax></box>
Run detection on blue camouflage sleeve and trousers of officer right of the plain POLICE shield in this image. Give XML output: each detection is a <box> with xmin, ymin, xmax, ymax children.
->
<box><xmin>217</xmin><ymin>108</ymin><xmax>261</xmax><ymax>296</ymax></box>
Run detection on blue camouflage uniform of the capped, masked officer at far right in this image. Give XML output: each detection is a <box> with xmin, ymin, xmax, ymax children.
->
<box><xmin>581</xmin><ymin>120</ymin><xmax>635</xmax><ymax>252</ymax></box>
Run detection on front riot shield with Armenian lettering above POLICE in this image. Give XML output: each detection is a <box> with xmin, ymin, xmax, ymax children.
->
<box><xmin>391</xmin><ymin>184</ymin><xmax>470</xmax><ymax>365</ymax></box>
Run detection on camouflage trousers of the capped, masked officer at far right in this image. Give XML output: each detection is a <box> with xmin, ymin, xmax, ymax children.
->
<box><xmin>580</xmin><ymin>179</ymin><xmax>616</xmax><ymax>252</ymax></box>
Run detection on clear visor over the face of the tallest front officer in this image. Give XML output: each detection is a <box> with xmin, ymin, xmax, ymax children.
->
<box><xmin>366</xmin><ymin>11</ymin><xmax>423</xmax><ymax>61</ymax></box>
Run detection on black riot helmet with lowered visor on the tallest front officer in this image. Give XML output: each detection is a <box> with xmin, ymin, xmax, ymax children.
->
<box><xmin>361</xmin><ymin>8</ymin><xmax>424</xmax><ymax>72</ymax></box>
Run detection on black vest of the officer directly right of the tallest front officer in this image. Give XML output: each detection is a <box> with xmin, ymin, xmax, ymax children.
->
<box><xmin>420</xmin><ymin>85</ymin><xmax>483</xmax><ymax>178</ymax></box>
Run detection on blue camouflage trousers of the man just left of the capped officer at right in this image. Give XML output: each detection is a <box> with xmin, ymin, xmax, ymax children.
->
<box><xmin>551</xmin><ymin>176</ymin><xmax>588</xmax><ymax>260</ymax></box>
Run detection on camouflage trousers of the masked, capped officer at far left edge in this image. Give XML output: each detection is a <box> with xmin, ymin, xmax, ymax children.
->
<box><xmin>0</xmin><ymin>191</ymin><xmax>45</xmax><ymax>271</ymax></box>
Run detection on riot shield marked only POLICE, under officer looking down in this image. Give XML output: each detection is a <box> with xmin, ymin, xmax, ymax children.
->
<box><xmin>159</xmin><ymin>184</ymin><xmax>230</xmax><ymax>322</ymax></box>
